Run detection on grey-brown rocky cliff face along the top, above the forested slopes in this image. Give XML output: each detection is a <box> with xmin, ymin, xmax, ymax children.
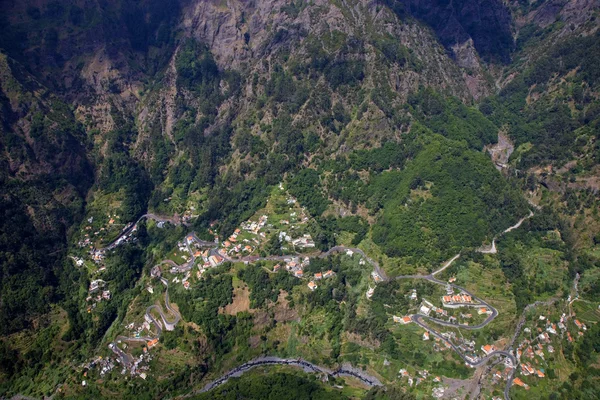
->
<box><xmin>0</xmin><ymin>0</ymin><xmax>599</xmax><ymax>216</ymax></box>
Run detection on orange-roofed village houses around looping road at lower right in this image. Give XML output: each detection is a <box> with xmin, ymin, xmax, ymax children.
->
<box><xmin>390</xmin><ymin>268</ymin><xmax>600</xmax><ymax>399</ymax></box>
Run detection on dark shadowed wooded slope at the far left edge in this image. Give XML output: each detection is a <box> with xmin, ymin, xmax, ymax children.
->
<box><xmin>0</xmin><ymin>54</ymin><xmax>94</xmax><ymax>334</ymax></box>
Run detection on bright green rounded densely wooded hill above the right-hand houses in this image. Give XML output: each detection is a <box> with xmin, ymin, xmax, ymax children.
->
<box><xmin>373</xmin><ymin>137</ymin><xmax>526</xmax><ymax>265</ymax></box>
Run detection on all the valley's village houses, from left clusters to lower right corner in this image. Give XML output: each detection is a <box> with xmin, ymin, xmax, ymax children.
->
<box><xmin>71</xmin><ymin>186</ymin><xmax>586</xmax><ymax>398</ymax></box>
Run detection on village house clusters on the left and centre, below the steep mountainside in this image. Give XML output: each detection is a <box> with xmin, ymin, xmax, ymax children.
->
<box><xmin>72</xmin><ymin>186</ymin><xmax>382</xmax><ymax>386</ymax></box>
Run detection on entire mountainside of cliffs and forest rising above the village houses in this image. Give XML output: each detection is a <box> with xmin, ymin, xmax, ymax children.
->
<box><xmin>0</xmin><ymin>0</ymin><xmax>600</xmax><ymax>393</ymax></box>
